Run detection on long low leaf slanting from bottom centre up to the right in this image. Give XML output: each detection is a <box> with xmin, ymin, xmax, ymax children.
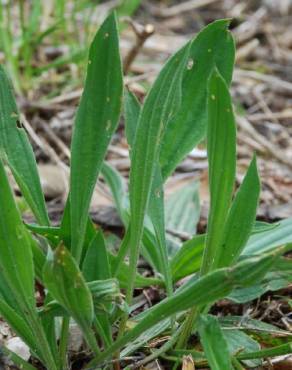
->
<box><xmin>90</xmin><ymin>248</ymin><xmax>285</xmax><ymax>365</ymax></box>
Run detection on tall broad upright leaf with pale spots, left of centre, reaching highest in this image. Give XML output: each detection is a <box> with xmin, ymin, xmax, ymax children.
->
<box><xmin>70</xmin><ymin>14</ymin><xmax>123</xmax><ymax>260</ymax></box>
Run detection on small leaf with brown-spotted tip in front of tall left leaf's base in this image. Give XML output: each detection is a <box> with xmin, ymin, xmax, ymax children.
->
<box><xmin>43</xmin><ymin>244</ymin><xmax>99</xmax><ymax>354</ymax></box>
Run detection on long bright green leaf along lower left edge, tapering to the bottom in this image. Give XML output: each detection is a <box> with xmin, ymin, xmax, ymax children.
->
<box><xmin>0</xmin><ymin>160</ymin><xmax>56</xmax><ymax>370</ymax></box>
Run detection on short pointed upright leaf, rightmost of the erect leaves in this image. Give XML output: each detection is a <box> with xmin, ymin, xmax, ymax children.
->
<box><xmin>215</xmin><ymin>158</ymin><xmax>260</xmax><ymax>267</ymax></box>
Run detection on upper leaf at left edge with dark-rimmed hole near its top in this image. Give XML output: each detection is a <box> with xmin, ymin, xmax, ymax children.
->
<box><xmin>0</xmin><ymin>66</ymin><xmax>49</xmax><ymax>225</ymax></box>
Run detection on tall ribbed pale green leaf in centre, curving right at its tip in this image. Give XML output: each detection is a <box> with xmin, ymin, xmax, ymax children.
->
<box><xmin>128</xmin><ymin>44</ymin><xmax>189</xmax><ymax>296</ymax></box>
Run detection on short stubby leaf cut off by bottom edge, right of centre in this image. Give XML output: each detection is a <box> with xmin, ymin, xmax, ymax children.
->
<box><xmin>198</xmin><ymin>315</ymin><xmax>232</xmax><ymax>370</ymax></box>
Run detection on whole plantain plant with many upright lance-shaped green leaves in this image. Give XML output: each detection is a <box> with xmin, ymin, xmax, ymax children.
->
<box><xmin>0</xmin><ymin>14</ymin><xmax>292</xmax><ymax>370</ymax></box>
